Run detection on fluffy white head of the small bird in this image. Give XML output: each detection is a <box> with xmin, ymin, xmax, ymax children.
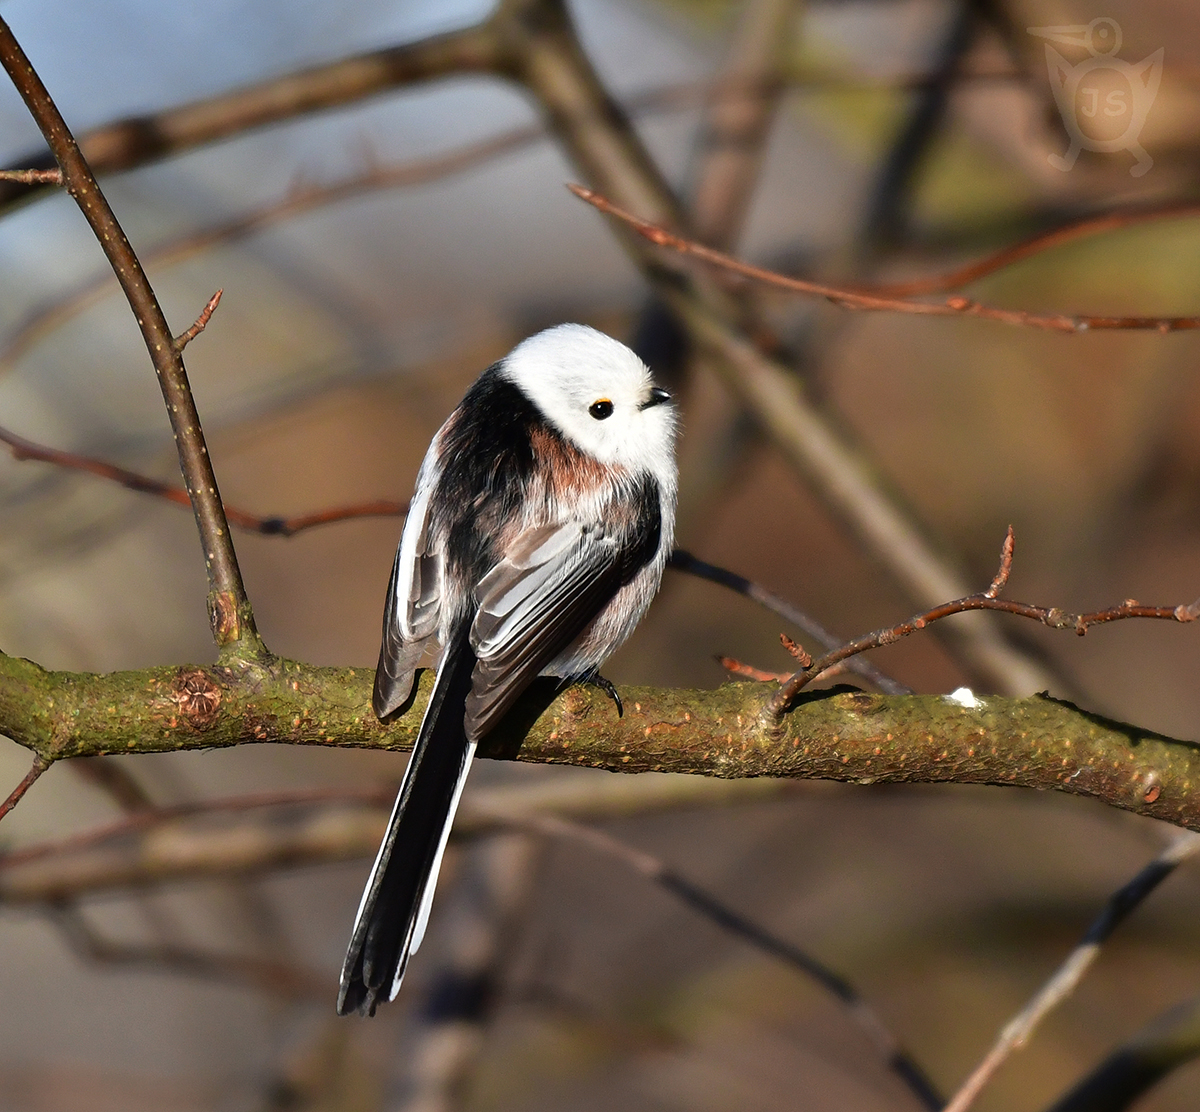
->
<box><xmin>503</xmin><ymin>324</ymin><xmax>676</xmax><ymax>477</ymax></box>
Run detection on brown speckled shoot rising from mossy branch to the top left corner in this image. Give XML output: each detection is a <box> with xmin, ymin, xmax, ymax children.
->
<box><xmin>0</xmin><ymin>19</ymin><xmax>265</xmax><ymax>657</ymax></box>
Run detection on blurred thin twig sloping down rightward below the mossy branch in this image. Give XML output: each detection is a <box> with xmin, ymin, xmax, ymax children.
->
<box><xmin>498</xmin><ymin>815</ymin><xmax>940</xmax><ymax>1112</ymax></box>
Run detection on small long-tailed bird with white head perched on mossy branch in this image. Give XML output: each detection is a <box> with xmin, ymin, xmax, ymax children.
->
<box><xmin>337</xmin><ymin>324</ymin><xmax>678</xmax><ymax>1016</ymax></box>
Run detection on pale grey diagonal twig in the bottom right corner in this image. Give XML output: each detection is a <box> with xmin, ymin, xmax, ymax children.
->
<box><xmin>944</xmin><ymin>833</ymin><xmax>1200</xmax><ymax>1112</ymax></box>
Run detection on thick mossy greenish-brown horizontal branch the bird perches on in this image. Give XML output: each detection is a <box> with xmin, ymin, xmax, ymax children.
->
<box><xmin>0</xmin><ymin>654</ymin><xmax>1200</xmax><ymax>830</ymax></box>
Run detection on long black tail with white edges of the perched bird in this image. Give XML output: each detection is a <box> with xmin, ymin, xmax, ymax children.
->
<box><xmin>337</xmin><ymin>625</ymin><xmax>475</xmax><ymax>1015</ymax></box>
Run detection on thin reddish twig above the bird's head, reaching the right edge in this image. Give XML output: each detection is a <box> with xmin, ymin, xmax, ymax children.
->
<box><xmin>568</xmin><ymin>184</ymin><xmax>1200</xmax><ymax>333</ymax></box>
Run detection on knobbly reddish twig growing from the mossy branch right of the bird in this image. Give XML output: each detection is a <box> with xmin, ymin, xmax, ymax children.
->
<box><xmin>770</xmin><ymin>525</ymin><xmax>1200</xmax><ymax>717</ymax></box>
